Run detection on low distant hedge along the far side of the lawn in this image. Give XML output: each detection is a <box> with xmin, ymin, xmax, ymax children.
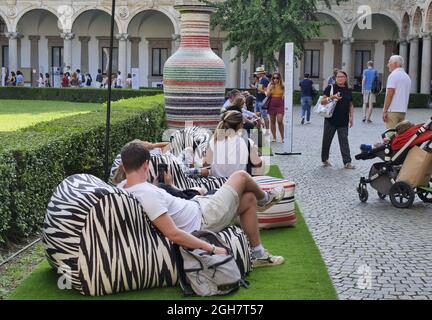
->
<box><xmin>0</xmin><ymin>87</ymin><xmax>161</xmax><ymax>103</ymax></box>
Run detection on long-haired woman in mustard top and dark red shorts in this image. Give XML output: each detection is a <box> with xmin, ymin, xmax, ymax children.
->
<box><xmin>267</xmin><ymin>72</ymin><xmax>285</xmax><ymax>143</ymax></box>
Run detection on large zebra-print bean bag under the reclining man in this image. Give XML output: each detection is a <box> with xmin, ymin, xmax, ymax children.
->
<box><xmin>43</xmin><ymin>174</ymin><xmax>251</xmax><ymax>296</ymax></box>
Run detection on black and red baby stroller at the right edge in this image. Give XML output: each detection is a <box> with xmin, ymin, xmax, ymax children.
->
<box><xmin>355</xmin><ymin>118</ymin><xmax>432</xmax><ymax>208</ymax></box>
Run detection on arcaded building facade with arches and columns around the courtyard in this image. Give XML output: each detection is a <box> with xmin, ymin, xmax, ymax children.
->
<box><xmin>0</xmin><ymin>0</ymin><xmax>432</xmax><ymax>94</ymax></box>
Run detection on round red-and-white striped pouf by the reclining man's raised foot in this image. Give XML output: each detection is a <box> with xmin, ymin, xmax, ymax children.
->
<box><xmin>254</xmin><ymin>176</ymin><xmax>297</xmax><ymax>229</ymax></box>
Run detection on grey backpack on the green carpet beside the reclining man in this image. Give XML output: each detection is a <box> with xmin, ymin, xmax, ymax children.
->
<box><xmin>180</xmin><ymin>230</ymin><xmax>247</xmax><ymax>296</ymax></box>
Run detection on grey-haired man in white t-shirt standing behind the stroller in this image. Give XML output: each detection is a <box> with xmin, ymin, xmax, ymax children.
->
<box><xmin>383</xmin><ymin>55</ymin><xmax>411</xmax><ymax>129</ymax></box>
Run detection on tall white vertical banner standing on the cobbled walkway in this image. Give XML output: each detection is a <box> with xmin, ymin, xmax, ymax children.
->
<box><xmin>284</xmin><ymin>42</ymin><xmax>294</xmax><ymax>153</ymax></box>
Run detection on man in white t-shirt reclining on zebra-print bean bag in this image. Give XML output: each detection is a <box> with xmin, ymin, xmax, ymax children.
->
<box><xmin>118</xmin><ymin>140</ymin><xmax>284</xmax><ymax>267</ymax></box>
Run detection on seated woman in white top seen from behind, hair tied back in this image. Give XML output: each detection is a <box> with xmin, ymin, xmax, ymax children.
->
<box><xmin>204</xmin><ymin>110</ymin><xmax>264</xmax><ymax>177</ymax></box>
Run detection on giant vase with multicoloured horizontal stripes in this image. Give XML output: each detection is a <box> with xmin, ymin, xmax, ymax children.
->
<box><xmin>163</xmin><ymin>5</ymin><xmax>226</xmax><ymax>129</ymax></box>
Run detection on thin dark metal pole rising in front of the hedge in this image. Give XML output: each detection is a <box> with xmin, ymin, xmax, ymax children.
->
<box><xmin>104</xmin><ymin>0</ymin><xmax>115</xmax><ymax>182</ymax></box>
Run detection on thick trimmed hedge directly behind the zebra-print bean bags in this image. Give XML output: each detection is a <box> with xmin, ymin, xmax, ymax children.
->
<box><xmin>0</xmin><ymin>96</ymin><xmax>166</xmax><ymax>242</ymax></box>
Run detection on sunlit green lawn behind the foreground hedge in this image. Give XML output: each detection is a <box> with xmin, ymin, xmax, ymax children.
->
<box><xmin>0</xmin><ymin>99</ymin><xmax>102</xmax><ymax>131</ymax></box>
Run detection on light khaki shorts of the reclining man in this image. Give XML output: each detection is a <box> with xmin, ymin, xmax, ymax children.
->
<box><xmin>192</xmin><ymin>184</ymin><xmax>240</xmax><ymax>232</ymax></box>
